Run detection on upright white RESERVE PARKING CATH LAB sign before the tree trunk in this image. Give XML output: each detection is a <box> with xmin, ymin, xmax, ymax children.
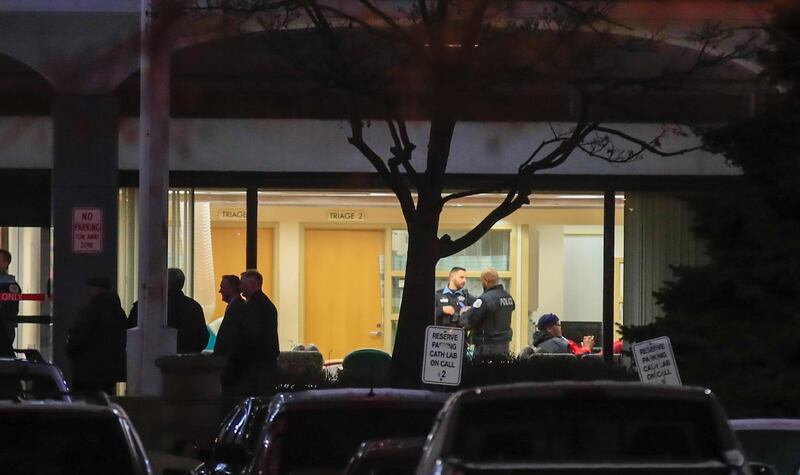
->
<box><xmin>422</xmin><ymin>325</ymin><xmax>464</xmax><ymax>386</ymax></box>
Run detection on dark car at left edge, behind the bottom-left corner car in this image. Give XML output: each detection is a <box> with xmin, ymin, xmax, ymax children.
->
<box><xmin>0</xmin><ymin>350</ymin><xmax>71</xmax><ymax>401</ymax></box>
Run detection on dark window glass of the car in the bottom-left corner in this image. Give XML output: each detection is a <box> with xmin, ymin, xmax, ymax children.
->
<box><xmin>0</xmin><ymin>411</ymin><xmax>133</xmax><ymax>475</ymax></box>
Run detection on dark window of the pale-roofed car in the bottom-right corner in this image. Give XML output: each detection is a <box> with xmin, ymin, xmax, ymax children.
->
<box><xmin>736</xmin><ymin>430</ymin><xmax>800</xmax><ymax>475</ymax></box>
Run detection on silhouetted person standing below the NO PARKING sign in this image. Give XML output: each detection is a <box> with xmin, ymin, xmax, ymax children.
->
<box><xmin>67</xmin><ymin>277</ymin><xmax>127</xmax><ymax>394</ymax></box>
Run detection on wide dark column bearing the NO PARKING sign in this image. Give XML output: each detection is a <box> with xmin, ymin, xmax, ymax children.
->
<box><xmin>52</xmin><ymin>95</ymin><xmax>119</xmax><ymax>374</ymax></box>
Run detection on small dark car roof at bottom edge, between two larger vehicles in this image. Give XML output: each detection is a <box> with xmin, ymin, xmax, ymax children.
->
<box><xmin>344</xmin><ymin>437</ymin><xmax>425</xmax><ymax>475</ymax></box>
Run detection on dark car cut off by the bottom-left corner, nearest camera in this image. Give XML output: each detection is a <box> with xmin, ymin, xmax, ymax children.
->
<box><xmin>0</xmin><ymin>401</ymin><xmax>152</xmax><ymax>475</ymax></box>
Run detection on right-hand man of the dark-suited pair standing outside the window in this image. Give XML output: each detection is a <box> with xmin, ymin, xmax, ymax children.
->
<box><xmin>222</xmin><ymin>270</ymin><xmax>280</xmax><ymax>396</ymax></box>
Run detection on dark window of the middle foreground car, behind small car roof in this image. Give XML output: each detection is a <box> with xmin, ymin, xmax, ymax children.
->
<box><xmin>277</xmin><ymin>405</ymin><xmax>439</xmax><ymax>474</ymax></box>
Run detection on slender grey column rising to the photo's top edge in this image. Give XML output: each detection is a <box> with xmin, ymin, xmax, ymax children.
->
<box><xmin>128</xmin><ymin>0</ymin><xmax>177</xmax><ymax>396</ymax></box>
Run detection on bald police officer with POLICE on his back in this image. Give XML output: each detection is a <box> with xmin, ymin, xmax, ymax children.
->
<box><xmin>461</xmin><ymin>268</ymin><xmax>516</xmax><ymax>358</ymax></box>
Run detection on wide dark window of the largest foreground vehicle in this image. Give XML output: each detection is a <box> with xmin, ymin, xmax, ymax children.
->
<box><xmin>445</xmin><ymin>399</ymin><xmax>720</xmax><ymax>463</ymax></box>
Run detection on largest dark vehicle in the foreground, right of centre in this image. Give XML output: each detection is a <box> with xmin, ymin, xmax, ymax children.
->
<box><xmin>417</xmin><ymin>382</ymin><xmax>751</xmax><ymax>474</ymax></box>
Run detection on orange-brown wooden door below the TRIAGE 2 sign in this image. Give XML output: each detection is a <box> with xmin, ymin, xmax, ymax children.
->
<box><xmin>303</xmin><ymin>229</ymin><xmax>384</xmax><ymax>359</ymax></box>
